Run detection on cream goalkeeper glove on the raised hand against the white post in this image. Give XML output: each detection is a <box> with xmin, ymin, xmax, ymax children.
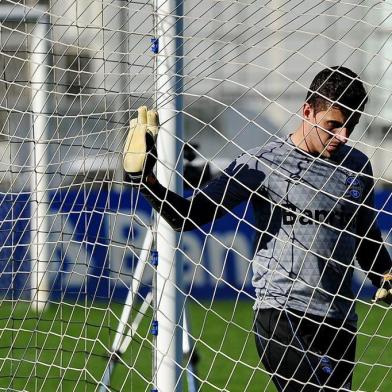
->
<box><xmin>123</xmin><ymin>106</ymin><xmax>159</xmax><ymax>184</ymax></box>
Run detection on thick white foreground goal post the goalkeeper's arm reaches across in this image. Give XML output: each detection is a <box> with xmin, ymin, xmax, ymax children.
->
<box><xmin>154</xmin><ymin>0</ymin><xmax>184</xmax><ymax>392</ymax></box>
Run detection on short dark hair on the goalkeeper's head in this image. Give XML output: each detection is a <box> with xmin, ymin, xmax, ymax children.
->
<box><xmin>306</xmin><ymin>66</ymin><xmax>368</xmax><ymax>113</ymax></box>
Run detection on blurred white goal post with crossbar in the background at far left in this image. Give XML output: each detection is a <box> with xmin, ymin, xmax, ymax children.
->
<box><xmin>0</xmin><ymin>5</ymin><xmax>52</xmax><ymax>311</ymax></box>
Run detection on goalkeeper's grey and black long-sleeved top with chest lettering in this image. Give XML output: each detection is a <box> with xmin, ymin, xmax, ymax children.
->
<box><xmin>139</xmin><ymin>138</ymin><xmax>392</xmax><ymax>324</ymax></box>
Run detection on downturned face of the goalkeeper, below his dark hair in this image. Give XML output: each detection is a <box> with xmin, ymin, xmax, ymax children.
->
<box><xmin>303</xmin><ymin>103</ymin><xmax>360</xmax><ymax>158</ymax></box>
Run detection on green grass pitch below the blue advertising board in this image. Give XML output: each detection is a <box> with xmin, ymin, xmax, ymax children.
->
<box><xmin>0</xmin><ymin>301</ymin><xmax>392</xmax><ymax>392</ymax></box>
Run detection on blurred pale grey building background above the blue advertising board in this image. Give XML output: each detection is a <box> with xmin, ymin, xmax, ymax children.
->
<box><xmin>0</xmin><ymin>0</ymin><xmax>392</xmax><ymax>190</ymax></box>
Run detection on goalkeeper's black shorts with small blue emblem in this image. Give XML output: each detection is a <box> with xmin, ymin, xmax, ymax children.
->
<box><xmin>254</xmin><ymin>309</ymin><xmax>356</xmax><ymax>392</ymax></box>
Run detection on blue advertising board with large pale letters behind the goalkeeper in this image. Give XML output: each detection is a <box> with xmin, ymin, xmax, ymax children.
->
<box><xmin>0</xmin><ymin>187</ymin><xmax>392</xmax><ymax>302</ymax></box>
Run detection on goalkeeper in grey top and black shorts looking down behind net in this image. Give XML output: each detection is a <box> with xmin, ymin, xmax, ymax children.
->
<box><xmin>124</xmin><ymin>67</ymin><xmax>392</xmax><ymax>392</ymax></box>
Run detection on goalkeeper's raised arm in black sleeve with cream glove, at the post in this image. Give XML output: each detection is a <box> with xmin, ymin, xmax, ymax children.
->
<box><xmin>123</xmin><ymin>107</ymin><xmax>254</xmax><ymax>231</ymax></box>
